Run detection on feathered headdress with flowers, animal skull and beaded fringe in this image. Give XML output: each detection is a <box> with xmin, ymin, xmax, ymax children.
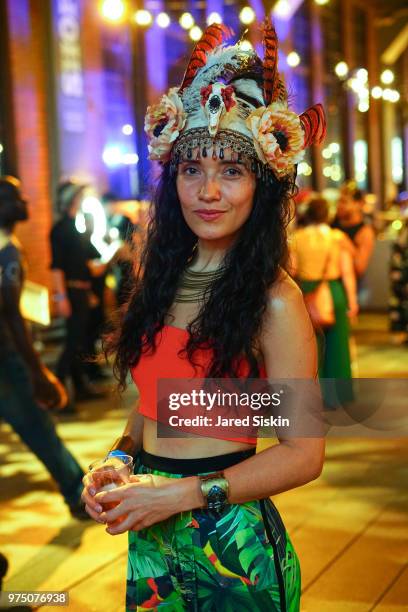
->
<box><xmin>145</xmin><ymin>19</ymin><xmax>326</xmax><ymax>179</ymax></box>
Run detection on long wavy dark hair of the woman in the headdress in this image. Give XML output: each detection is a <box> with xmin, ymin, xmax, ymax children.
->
<box><xmin>105</xmin><ymin>165</ymin><xmax>293</xmax><ymax>391</ymax></box>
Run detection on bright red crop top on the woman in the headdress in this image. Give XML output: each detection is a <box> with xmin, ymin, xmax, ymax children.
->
<box><xmin>131</xmin><ymin>325</ymin><xmax>266</xmax><ymax>444</ymax></box>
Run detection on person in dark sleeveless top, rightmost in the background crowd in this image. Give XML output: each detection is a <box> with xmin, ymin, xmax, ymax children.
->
<box><xmin>332</xmin><ymin>188</ymin><xmax>375</xmax><ymax>278</ymax></box>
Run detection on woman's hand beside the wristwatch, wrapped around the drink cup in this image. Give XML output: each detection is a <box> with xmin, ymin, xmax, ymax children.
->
<box><xmin>94</xmin><ymin>474</ymin><xmax>203</xmax><ymax>535</ymax></box>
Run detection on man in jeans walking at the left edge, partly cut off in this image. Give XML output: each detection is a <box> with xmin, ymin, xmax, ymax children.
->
<box><xmin>0</xmin><ymin>177</ymin><xmax>87</xmax><ymax>518</ymax></box>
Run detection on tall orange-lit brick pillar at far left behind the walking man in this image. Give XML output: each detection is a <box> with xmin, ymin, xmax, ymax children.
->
<box><xmin>7</xmin><ymin>0</ymin><xmax>52</xmax><ymax>285</ymax></box>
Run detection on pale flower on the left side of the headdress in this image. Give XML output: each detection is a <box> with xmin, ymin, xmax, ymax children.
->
<box><xmin>144</xmin><ymin>87</ymin><xmax>187</xmax><ymax>162</ymax></box>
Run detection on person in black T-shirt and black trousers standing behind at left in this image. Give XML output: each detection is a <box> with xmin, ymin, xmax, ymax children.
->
<box><xmin>50</xmin><ymin>181</ymin><xmax>106</xmax><ymax>401</ymax></box>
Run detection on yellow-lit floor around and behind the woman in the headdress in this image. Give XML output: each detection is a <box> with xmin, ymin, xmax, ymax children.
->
<box><xmin>0</xmin><ymin>317</ymin><xmax>408</xmax><ymax>612</ymax></box>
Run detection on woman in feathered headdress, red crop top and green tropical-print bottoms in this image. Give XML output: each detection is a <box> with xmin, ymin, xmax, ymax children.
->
<box><xmin>83</xmin><ymin>23</ymin><xmax>324</xmax><ymax>611</ymax></box>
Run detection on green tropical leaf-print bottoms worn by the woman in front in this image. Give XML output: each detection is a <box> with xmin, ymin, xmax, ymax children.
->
<box><xmin>126</xmin><ymin>456</ymin><xmax>300</xmax><ymax>612</ymax></box>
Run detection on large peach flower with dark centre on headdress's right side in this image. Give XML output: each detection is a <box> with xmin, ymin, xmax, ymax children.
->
<box><xmin>246</xmin><ymin>102</ymin><xmax>304</xmax><ymax>178</ymax></box>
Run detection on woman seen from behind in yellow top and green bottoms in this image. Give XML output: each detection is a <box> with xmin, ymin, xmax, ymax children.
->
<box><xmin>292</xmin><ymin>198</ymin><xmax>358</xmax><ymax>379</ymax></box>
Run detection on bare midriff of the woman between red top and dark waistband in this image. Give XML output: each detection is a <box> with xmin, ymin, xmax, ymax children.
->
<box><xmin>143</xmin><ymin>417</ymin><xmax>254</xmax><ymax>459</ymax></box>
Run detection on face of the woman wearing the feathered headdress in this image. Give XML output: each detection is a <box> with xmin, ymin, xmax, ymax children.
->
<box><xmin>177</xmin><ymin>149</ymin><xmax>256</xmax><ymax>246</ymax></box>
